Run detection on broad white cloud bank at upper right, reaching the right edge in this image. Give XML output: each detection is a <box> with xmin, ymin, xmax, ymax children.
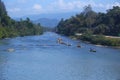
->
<box><xmin>46</xmin><ymin>0</ymin><xmax>120</xmax><ymax>12</ymax></box>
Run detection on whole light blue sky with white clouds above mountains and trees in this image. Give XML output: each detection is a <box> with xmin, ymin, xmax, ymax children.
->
<box><xmin>2</xmin><ymin>0</ymin><xmax>120</xmax><ymax>17</ymax></box>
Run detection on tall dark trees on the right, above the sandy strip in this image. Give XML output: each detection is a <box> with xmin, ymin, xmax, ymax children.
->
<box><xmin>57</xmin><ymin>5</ymin><xmax>120</xmax><ymax>36</ymax></box>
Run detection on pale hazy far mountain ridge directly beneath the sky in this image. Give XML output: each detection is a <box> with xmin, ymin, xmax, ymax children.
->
<box><xmin>13</xmin><ymin>12</ymin><xmax>78</xmax><ymax>21</ymax></box>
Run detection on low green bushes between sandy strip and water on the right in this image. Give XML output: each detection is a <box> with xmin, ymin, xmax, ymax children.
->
<box><xmin>79</xmin><ymin>34</ymin><xmax>120</xmax><ymax>46</ymax></box>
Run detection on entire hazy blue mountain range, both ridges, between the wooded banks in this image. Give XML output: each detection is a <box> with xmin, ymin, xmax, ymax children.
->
<box><xmin>14</xmin><ymin>12</ymin><xmax>77</xmax><ymax>28</ymax></box>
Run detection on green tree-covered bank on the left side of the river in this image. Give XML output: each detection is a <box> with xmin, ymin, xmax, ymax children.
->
<box><xmin>0</xmin><ymin>0</ymin><xmax>42</xmax><ymax>39</ymax></box>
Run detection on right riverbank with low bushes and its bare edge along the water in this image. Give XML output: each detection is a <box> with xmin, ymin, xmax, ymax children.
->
<box><xmin>70</xmin><ymin>34</ymin><xmax>120</xmax><ymax>48</ymax></box>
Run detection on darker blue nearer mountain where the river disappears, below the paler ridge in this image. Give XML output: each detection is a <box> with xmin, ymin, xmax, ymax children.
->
<box><xmin>33</xmin><ymin>18</ymin><xmax>59</xmax><ymax>28</ymax></box>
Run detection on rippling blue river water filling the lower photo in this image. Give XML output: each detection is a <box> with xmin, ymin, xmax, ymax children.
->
<box><xmin>0</xmin><ymin>32</ymin><xmax>120</xmax><ymax>80</ymax></box>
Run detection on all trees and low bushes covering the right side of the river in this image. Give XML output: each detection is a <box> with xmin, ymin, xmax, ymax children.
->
<box><xmin>56</xmin><ymin>5</ymin><xmax>120</xmax><ymax>46</ymax></box>
